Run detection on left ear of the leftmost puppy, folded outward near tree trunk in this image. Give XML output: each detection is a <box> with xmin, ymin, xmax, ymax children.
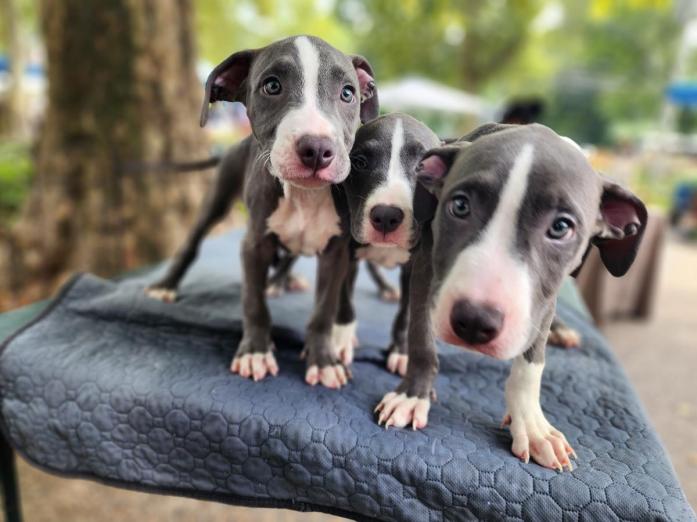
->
<box><xmin>201</xmin><ymin>50</ymin><xmax>256</xmax><ymax>127</ymax></box>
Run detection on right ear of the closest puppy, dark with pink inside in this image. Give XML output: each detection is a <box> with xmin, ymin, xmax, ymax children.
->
<box><xmin>592</xmin><ymin>181</ymin><xmax>648</xmax><ymax>277</ymax></box>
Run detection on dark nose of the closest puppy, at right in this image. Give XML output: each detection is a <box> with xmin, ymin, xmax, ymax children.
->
<box><xmin>450</xmin><ymin>299</ymin><xmax>503</xmax><ymax>345</ymax></box>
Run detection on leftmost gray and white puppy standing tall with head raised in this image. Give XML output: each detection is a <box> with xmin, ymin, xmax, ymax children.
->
<box><xmin>147</xmin><ymin>36</ymin><xmax>378</xmax><ymax>388</ymax></box>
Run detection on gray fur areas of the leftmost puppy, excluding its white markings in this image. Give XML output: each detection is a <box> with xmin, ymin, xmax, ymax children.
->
<box><xmin>145</xmin><ymin>37</ymin><xmax>377</xmax><ymax>378</ymax></box>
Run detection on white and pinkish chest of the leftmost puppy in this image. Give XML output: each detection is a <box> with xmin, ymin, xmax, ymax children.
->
<box><xmin>266</xmin><ymin>186</ymin><xmax>341</xmax><ymax>256</ymax></box>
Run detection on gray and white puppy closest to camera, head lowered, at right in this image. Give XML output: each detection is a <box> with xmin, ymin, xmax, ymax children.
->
<box><xmin>376</xmin><ymin>125</ymin><xmax>647</xmax><ymax>469</ymax></box>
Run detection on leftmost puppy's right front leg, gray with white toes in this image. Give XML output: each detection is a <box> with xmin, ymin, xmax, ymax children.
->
<box><xmin>303</xmin><ymin>237</ymin><xmax>349</xmax><ymax>388</ymax></box>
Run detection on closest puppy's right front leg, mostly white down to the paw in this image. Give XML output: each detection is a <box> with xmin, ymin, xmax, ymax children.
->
<box><xmin>503</xmin><ymin>310</ymin><xmax>576</xmax><ymax>471</ymax></box>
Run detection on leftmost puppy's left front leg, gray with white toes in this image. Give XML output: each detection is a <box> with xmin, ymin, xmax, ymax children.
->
<box><xmin>230</xmin><ymin>231</ymin><xmax>278</xmax><ymax>381</ymax></box>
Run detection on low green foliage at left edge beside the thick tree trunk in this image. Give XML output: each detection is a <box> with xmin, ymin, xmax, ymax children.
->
<box><xmin>0</xmin><ymin>142</ymin><xmax>33</xmax><ymax>224</ymax></box>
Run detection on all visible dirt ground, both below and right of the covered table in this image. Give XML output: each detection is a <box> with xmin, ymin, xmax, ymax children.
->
<box><xmin>0</xmin><ymin>240</ymin><xmax>697</xmax><ymax>522</ymax></box>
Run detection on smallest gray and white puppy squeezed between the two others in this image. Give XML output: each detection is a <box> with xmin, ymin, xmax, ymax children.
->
<box><xmin>333</xmin><ymin>113</ymin><xmax>441</xmax><ymax>375</ymax></box>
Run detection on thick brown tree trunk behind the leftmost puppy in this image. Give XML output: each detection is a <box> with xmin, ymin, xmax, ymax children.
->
<box><xmin>0</xmin><ymin>0</ymin><xmax>209</xmax><ymax>299</ymax></box>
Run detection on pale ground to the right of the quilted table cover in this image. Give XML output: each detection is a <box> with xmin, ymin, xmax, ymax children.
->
<box><xmin>604</xmin><ymin>238</ymin><xmax>697</xmax><ymax>510</ymax></box>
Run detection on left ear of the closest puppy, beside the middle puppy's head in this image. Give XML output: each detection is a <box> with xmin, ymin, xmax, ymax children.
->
<box><xmin>414</xmin><ymin>141</ymin><xmax>462</xmax><ymax>223</ymax></box>
